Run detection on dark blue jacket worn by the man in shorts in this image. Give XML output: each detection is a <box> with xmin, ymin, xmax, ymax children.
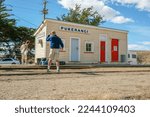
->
<box><xmin>46</xmin><ymin>35</ymin><xmax>64</xmax><ymax>49</ymax></box>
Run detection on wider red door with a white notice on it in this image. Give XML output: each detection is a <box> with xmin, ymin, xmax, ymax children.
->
<box><xmin>111</xmin><ymin>39</ymin><xmax>118</xmax><ymax>62</ymax></box>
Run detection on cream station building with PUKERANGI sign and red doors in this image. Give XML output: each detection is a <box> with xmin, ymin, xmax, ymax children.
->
<box><xmin>34</xmin><ymin>19</ymin><xmax>128</xmax><ymax>64</ymax></box>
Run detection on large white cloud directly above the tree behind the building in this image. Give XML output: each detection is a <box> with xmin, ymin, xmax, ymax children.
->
<box><xmin>58</xmin><ymin>0</ymin><xmax>133</xmax><ymax>24</ymax></box>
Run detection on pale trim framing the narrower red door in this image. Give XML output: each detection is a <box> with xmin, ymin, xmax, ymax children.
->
<box><xmin>99</xmin><ymin>34</ymin><xmax>110</xmax><ymax>63</ymax></box>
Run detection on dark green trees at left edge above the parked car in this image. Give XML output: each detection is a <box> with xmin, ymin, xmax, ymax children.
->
<box><xmin>0</xmin><ymin>0</ymin><xmax>35</xmax><ymax>51</ymax></box>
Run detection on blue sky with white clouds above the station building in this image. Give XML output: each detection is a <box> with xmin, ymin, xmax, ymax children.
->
<box><xmin>5</xmin><ymin>0</ymin><xmax>150</xmax><ymax>50</ymax></box>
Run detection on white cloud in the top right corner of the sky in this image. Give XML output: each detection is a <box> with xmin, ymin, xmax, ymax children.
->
<box><xmin>111</xmin><ymin>0</ymin><xmax>150</xmax><ymax>12</ymax></box>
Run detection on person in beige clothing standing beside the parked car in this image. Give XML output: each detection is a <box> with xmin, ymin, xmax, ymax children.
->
<box><xmin>20</xmin><ymin>40</ymin><xmax>29</xmax><ymax>64</ymax></box>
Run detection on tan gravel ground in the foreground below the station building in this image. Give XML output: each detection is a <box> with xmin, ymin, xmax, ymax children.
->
<box><xmin>0</xmin><ymin>67</ymin><xmax>150</xmax><ymax>100</ymax></box>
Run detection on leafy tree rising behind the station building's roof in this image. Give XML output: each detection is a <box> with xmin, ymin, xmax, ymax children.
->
<box><xmin>57</xmin><ymin>5</ymin><xmax>103</xmax><ymax>26</ymax></box>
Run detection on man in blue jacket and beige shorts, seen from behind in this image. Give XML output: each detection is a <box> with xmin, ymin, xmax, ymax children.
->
<box><xmin>46</xmin><ymin>31</ymin><xmax>64</xmax><ymax>73</ymax></box>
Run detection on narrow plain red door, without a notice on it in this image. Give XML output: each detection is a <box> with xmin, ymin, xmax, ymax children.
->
<box><xmin>100</xmin><ymin>41</ymin><xmax>105</xmax><ymax>62</ymax></box>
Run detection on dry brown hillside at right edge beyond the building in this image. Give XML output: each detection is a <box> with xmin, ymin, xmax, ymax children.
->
<box><xmin>136</xmin><ymin>51</ymin><xmax>150</xmax><ymax>64</ymax></box>
